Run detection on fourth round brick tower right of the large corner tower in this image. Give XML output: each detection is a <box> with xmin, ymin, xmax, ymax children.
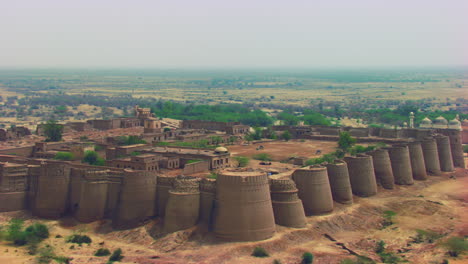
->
<box><xmin>344</xmin><ymin>154</ymin><xmax>377</xmax><ymax>197</ymax></box>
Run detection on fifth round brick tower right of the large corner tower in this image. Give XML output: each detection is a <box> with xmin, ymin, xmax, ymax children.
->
<box><xmin>367</xmin><ymin>149</ymin><xmax>395</xmax><ymax>190</ymax></box>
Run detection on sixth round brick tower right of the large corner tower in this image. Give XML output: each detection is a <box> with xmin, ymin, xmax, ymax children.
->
<box><xmin>388</xmin><ymin>145</ymin><xmax>414</xmax><ymax>185</ymax></box>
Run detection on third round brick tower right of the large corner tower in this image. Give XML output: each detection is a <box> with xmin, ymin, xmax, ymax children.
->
<box><xmin>326</xmin><ymin>160</ymin><xmax>353</xmax><ymax>204</ymax></box>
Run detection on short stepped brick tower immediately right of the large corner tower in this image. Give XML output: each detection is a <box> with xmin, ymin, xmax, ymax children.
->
<box><xmin>270</xmin><ymin>178</ymin><xmax>306</xmax><ymax>228</ymax></box>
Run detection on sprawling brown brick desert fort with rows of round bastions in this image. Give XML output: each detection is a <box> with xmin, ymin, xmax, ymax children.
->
<box><xmin>0</xmin><ymin>107</ymin><xmax>465</xmax><ymax>241</ymax></box>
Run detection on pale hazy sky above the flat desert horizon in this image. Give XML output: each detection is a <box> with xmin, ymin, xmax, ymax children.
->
<box><xmin>0</xmin><ymin>0</ymin><xmax>468</xmax><ymax>68</ymax></box>
